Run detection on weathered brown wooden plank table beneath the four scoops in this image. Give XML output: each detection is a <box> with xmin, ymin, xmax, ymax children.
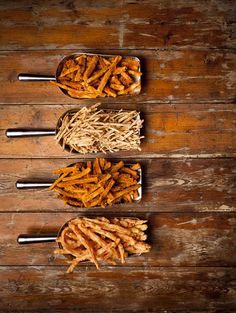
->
<box><xmin>0</xmin><ymin>0</ymin><xmax>236</xmax><ymax>312</ymax></box>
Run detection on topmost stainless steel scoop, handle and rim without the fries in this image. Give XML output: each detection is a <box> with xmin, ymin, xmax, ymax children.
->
<box><xmin>18</xmin><ymin>53</ymin><xmax>141</xmax><ymax>99</ymax></box>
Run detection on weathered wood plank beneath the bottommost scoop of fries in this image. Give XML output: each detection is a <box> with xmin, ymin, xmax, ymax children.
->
<box><xmin>0</xmin><ymin>210</ymin><xmax>236</xmax><ymax>264</ymax></box>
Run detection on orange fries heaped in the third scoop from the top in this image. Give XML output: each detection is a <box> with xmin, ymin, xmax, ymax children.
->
<box><xmin>49</xmin><ymin>158</ymin><xmax>141</xmax><ymax>208</ymax></box>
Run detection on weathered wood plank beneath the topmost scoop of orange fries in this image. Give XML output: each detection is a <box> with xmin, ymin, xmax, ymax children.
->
<box><xmin>0</xmin><ymin>50</ymin><xmax>236</xmax><ymax>104</ymax></box>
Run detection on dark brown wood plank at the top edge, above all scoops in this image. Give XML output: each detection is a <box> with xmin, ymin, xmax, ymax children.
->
<box><xmin>0</xmin><ymin>0</ymin><xmax>235</xmax><ymax>50</ymax></box>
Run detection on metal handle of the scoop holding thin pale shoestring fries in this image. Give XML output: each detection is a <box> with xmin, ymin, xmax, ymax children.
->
<box><xmin>6</xmin><ymin>128</ymin><xmax>56</xmax><ymax>138</ymax></box>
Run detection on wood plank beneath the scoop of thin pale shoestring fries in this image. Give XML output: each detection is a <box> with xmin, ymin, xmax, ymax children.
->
<box><xmin>0</xmin><ymin>104</ymin><xmax>236</xmax><ymax>158</ymax></box>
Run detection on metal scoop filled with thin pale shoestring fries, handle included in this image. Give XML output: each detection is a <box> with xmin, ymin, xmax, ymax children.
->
<box><xmin>6</xmin><ymin>103</ymin><xmax>143</xmax><ymax>154</ymax></box>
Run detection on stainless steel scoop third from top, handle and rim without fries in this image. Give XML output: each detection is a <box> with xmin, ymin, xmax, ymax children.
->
<box><xmin>16</xmin><ymin>163</ymin><xmax>142</xmax><ymax>202</ymax></box>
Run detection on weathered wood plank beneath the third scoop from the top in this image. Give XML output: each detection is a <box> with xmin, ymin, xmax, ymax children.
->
<box><xmin>0</xmin><ymin>159</ymin><xmax>236</xmax><ymax>214</ymax></box>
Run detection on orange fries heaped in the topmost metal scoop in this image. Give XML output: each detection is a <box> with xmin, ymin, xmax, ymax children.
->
<box><xmin>51</xmin><ymin>54</ymin><xmax>142</xmax><ymax>99</ymax></box>
